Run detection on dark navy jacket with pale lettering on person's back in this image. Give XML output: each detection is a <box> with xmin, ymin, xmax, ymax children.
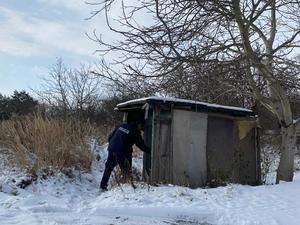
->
<box><xmin>107</xmin><ymin>123</ymin><xmax>150</xmax><ymax>156</ymax></box>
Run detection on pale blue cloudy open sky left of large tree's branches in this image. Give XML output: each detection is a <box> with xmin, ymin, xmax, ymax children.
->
<box><xmin>0</xmin><ymin>0</ymin><xmax>109</xmax><ymax>95</ymax></box>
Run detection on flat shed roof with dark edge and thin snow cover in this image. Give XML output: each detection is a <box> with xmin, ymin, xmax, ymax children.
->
<box><xmin>116</xmin><ymin>96</ymin><xmax>254</xmax><ymax>116</ymax></box>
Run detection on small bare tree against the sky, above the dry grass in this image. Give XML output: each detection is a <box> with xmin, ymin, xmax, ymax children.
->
<box><xmin>35</xmin><ymin>59</ymin><xmax>101</xmax><ymax>119</ymax></box>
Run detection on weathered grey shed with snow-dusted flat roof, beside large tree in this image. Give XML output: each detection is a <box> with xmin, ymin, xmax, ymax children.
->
<box><xmin>116</xmin><ymin>97</ymin><xmax>260</xmax><ymax>188</ymax></box>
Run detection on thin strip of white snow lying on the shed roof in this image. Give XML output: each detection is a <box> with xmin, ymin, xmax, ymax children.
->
<box><xmin>117</xmin><ymin>96</ymin><xmax>252</xmax><ymax>112</ymax></box>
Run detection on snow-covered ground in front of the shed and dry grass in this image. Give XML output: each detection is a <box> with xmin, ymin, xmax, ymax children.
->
<box><xmin>0</xmin><ymin>145</ymin><xmax>300</xmax><ymax>225</ymax></box>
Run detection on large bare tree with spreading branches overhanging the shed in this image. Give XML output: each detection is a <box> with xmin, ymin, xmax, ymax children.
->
<box><xmin>92</xmin><ymin>0</ymin><xmax>300</xmax><ymax>182</ymax></box>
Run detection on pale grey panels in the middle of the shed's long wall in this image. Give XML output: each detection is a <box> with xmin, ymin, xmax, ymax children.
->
<box><xmin>172</xmin><ymin>110</ymin><xmax>207</xmax><ymax>187</ymax></box>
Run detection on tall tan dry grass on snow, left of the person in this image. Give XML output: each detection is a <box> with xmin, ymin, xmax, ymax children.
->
<box><xmin>0</xmin><ymin>115</ymin><xmax>103</xmax><ymax>172</ymax></box>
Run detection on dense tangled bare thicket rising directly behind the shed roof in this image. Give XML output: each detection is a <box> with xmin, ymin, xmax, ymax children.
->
<box><xmin>160</xmin><ymin>62</ymin><xmax>253</xmax><ymax>107</ymax></box>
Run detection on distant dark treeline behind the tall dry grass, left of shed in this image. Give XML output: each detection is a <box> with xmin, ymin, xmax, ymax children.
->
<box><xmin>0</xmin><ymin>90</ymin><xmax>129</xmax><ymax>127</ymax></box>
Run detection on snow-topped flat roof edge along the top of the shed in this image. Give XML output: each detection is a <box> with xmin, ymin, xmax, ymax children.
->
<box><xmin>116</xmin><ymin>96</ymin><xmax>253</xmax><ymax>115</ymax></box>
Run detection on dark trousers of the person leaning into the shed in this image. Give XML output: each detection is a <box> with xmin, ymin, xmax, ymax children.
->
<box><xmin>100</xmin><ymin>152</ymin><xmax>131</xmax><ymax>189</ymax></box>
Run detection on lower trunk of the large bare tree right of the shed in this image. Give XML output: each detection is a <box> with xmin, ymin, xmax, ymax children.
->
<box><xmin>276</xmin><ymin>124</ymin><xmax>297</xmax><ymax>184</ymax></box>
